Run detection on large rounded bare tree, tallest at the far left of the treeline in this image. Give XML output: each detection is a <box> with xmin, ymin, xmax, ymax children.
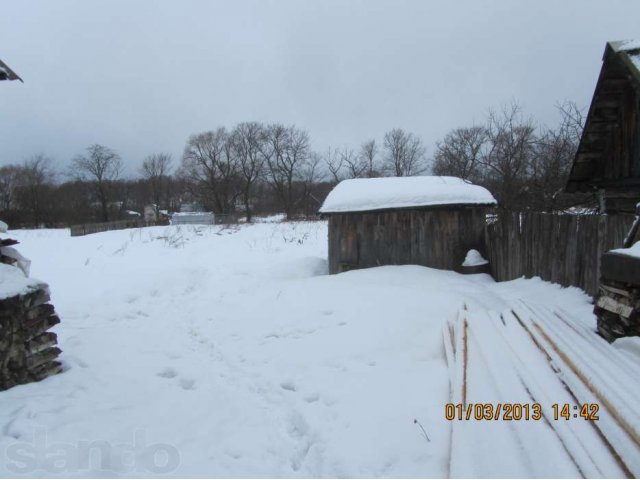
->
<box><xmin>71</xmin><ymin>144</ymin><xmax>122</xmax><ymax>222</ymax></box>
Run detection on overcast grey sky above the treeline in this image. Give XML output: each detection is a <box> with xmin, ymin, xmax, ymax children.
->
<box><xmin>0</xmin><ymin>0</ymin><xmax>640</xmax><ymax>173</ymax></box>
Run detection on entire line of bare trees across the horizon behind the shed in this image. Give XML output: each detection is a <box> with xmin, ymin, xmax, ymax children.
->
<box><xmin>0</xmin><ymin>103</ymin><xmax>584</xmax><ymax>226</ymax></box>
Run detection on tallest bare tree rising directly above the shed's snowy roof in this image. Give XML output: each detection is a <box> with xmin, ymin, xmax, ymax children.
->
<box><xmin>384</xmin><ymin>128</ymin><xmax>425</xmax><ymax>177</ymax></box>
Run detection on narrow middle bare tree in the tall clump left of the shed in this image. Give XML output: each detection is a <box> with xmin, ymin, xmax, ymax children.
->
<box><xmin>231</xmin><ymin>122</ymin><xmax>267</xmax><ymax>222</ymax></box>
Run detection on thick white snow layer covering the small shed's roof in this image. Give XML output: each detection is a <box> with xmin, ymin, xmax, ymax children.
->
<box><xmin>320</xmin><ymin>176</ymin><xmax>496</xmax><ymax>213</ymax></box>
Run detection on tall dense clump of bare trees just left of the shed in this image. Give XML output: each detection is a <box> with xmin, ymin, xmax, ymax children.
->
<box><xmin>177</xmin><ymin>122</ymin><xmax>319</xmax><ymax>221</ymax></box>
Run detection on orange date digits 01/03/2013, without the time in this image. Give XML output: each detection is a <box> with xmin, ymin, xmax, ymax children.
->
<box><xmin>444</xmin><ymin>403</ymin><xmax>542</xmax><ymax>421</ymax></box>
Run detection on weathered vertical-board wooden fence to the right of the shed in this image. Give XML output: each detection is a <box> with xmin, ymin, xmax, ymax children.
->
<box><xmin>485</xmin><ymin>213</ymin><xmax>635</xmax><ymax>295</ymax></box>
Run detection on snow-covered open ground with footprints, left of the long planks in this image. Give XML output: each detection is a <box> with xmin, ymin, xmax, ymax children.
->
<box><xmin>0</xmin><ymin>222</ymin><xmax>595</xmax><ymax>477</ymax></box>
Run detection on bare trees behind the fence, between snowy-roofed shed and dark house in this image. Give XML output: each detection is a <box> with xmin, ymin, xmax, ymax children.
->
<box><xmin>432</xmin><ymin>102</ymin><xmax>585</xmax><ymax>211</ymax></box>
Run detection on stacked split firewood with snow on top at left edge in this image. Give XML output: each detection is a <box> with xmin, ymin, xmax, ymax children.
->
<box><xmin>0</xmin><ymin>221</ymin><xmax>62</xmax><ymax>390</ymax></box>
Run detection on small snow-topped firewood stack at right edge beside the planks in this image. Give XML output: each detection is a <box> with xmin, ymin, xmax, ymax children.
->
<box><xmin>594</xmin><ymin>278</ymin><xmax>640</xmax><ymax>342</ymax></box>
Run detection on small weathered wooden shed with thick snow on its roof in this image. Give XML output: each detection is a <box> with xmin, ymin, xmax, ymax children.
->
<box><xmin>320</xmin><ymin>176</ymin><xmax>496</xmax><ymax>273</ymax></box>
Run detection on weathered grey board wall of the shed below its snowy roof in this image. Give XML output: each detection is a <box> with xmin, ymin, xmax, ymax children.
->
<box><xmin>329</xmin><ymin>207</ymin><xmax>486</xmax><ymax>273</ymax></box>
